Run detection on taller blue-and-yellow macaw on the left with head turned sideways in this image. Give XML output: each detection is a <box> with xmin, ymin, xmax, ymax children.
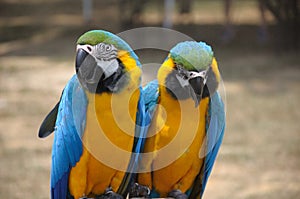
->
<box><xmin>39</xmin><ymin>30</ymin><xmax>149</xmax><ymax>199</ymax></box>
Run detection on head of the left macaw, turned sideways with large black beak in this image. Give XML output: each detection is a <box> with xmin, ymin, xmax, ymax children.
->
<box><xmin>75</xmin><ymin>30</ymin><xmax>139</xmax><ymax>93</ymax></box>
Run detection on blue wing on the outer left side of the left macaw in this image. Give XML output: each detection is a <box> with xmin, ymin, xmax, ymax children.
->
<box><xmin>51</xmin><ymin>75</ymin><xmax>87</xmax><ymax>199</ymax></box>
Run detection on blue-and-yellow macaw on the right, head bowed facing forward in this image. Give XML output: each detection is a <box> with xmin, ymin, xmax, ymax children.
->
<box><xmin>134</xmin><ymin>41</ymin><xmax>225</xmax><ymax>199</ymax></box>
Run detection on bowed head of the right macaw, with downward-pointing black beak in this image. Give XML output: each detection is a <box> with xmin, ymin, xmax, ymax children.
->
<box><xmin>164</xmin><ymin>41</ymin><xmax>220</xmax><ymax>107</ymax></box>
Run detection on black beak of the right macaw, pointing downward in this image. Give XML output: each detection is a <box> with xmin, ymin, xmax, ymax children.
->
<box><xmin>189</xmin><ymin>77</ymin><xmax>204</xmax><ymax>107</ymax></box>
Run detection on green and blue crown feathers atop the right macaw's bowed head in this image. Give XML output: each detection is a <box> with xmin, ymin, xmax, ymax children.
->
<box><xmin>170</xmin><ymin>41</ymin><xmax>214</xmax><ymax>71</ymax></box>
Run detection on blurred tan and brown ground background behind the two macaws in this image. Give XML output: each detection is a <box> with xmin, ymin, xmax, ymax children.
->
<box><xmin>0</xmin><ymin>0</ymin><xmax>300</xmax><ymax>199</ymax></box>
